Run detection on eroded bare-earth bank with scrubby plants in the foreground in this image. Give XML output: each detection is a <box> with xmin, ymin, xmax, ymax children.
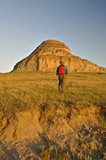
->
<box><xmin>0</xmin><ymin>104</ymin><xmax>106</xmax><ymax>160</ymax></box>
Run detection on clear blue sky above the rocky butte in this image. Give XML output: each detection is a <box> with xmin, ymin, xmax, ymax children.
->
<box><xmin>0</xmin><ymin>0</ymin><xmax>106</xmax><ymax>72</ymax></box>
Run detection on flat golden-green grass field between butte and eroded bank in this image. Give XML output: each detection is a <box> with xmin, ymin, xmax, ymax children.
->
<box><xmin>0</xmin><ymin>72</ymin><xmax>106</xmax><ymax>112</ymax></box>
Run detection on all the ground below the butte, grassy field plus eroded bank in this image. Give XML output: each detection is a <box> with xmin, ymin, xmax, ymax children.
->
<box><xmin>0</xmin><ymin>72</ymin><xmax>106</xmax><ymax>160</ymax></box>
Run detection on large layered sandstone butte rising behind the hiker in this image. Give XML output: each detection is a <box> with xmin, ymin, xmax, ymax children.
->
<box><xmin>13</xmin><ymin>40</ymin><xmax>106</xmax><ymax>72</ymax></box>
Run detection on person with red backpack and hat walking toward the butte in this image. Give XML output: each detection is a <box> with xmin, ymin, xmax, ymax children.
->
<box><xmin>56</xmin><ymin>60</ymin><xmax>68</xmax><ymax>92</ymax></box>
